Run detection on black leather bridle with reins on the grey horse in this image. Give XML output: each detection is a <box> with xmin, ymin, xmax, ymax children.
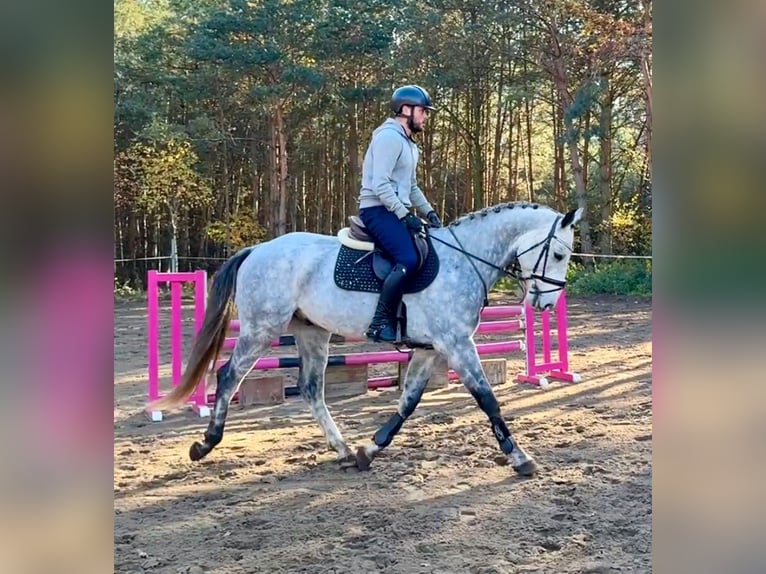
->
<box><xmin>426</xmin><ymin>217</ymin><xmax>572</xmax><ymax>307</ymax></box>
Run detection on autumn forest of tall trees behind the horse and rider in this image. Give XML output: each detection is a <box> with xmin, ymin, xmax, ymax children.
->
<box><xmin>114</xmin><ymin>0</ymin><xmax>652</xmax><ymax>294</ymax></box>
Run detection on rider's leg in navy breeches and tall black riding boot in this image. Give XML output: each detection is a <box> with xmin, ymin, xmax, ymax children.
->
<box><xmin>359</xmin><ymin>206</ymin><xmax>418</xmax><ymax>342</ymax></box>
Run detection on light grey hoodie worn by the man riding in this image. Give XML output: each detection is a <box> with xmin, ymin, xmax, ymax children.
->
<box><xmin>359</xmin><ymin>118</ymin><xmax>434</xmax><ymax>219</ymax></box>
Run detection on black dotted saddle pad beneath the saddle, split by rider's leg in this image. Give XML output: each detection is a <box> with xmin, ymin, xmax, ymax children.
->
<box><xmin>335</xmin><ymin>238</ymin><xmax>439</xmax><ymax>293</ymax></box>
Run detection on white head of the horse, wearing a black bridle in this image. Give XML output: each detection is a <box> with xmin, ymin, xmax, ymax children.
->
<box><xmin>512</xmin><ymin>208</ymin><xmax>583</xmax><ymax>311</ymax></box>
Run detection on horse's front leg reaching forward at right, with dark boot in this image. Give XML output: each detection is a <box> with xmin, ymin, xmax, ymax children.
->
<box><xmin>449</xmin><ymin>342</ymin><xmax>537</xmax><ymax>476</ymax></box>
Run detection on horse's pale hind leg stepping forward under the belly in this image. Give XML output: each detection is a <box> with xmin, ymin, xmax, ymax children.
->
<box><xmin>290</xmin><ymin>321</ymin><xmax>355</xmax><ymax>466</ymax></box>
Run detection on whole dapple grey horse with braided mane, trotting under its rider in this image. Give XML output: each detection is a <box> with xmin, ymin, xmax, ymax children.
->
<box><xmin>148</xmin><ymin>203</ymin><xmax>582</xmax><ymax>476</ymax></box>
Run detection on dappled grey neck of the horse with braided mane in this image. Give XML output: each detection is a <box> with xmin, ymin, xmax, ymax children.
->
<box><xmin>444</xmin><ymin>206</ymin><xmax>555</xmax><ymax>287</ymax></box>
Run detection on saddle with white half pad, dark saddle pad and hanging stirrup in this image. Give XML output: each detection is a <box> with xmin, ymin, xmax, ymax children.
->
<box><xmin>334</xmin><ymin>215</ymin><xmax>439</xmax><ymax>337</ymax></box>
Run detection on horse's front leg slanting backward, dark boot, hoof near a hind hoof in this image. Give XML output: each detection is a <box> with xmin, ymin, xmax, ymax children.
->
<box><xmin>356</xmin><ymin>349</ymin><xmax>437</xmax><ymax>470</ymax></box>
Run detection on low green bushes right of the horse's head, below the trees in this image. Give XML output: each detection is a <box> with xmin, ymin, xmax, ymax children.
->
<box><xmin>567</xmin><ymin>259</ymin><xmax>652</xmax><ymax>295</ymax></box>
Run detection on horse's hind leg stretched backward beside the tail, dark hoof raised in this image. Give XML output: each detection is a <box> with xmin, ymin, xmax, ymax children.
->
<box><xmin>189</xmin><ymin>332</ymin><xmax>273</xmax><ymax>460</ymax></box>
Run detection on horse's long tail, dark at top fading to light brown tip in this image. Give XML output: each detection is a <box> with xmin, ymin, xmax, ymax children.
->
<box><xmin>146</xmin><ymin>247</ymin><xmax>253</xmax><ymax>410</ymax></box>
